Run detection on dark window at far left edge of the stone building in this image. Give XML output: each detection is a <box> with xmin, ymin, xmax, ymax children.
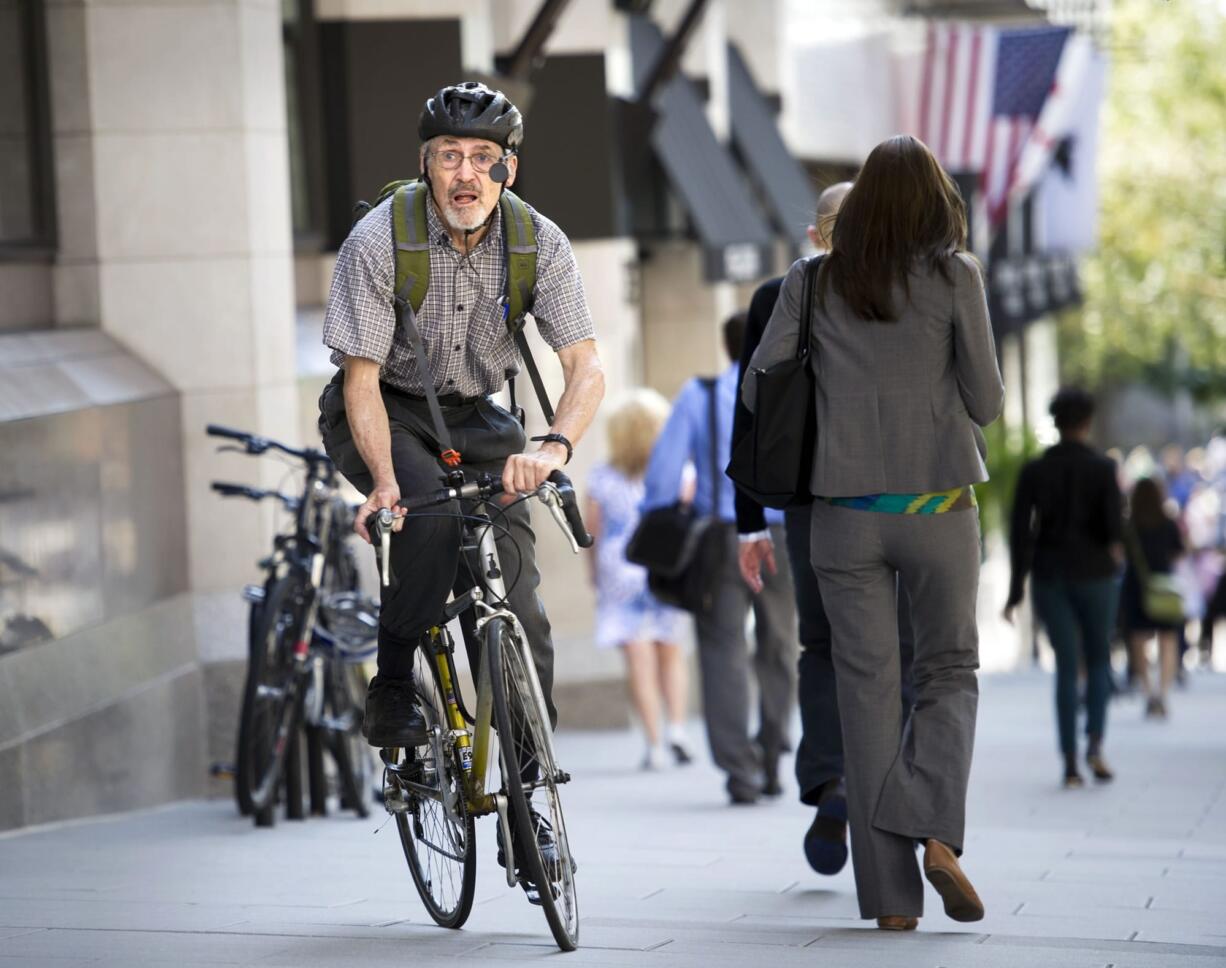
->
<box><xmin>0</xmin><ymin>0</ymin><xmax>55</xmax><ymax>257</ymax></box>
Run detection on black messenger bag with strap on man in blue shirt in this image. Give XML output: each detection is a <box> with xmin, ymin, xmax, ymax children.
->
<box><xmin>625</xmin><ymin>379</ymin><xmax>727</xmax><ymax>615</ymax></box>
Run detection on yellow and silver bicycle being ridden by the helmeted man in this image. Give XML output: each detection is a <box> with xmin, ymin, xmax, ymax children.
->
<box><xmin>367</xmin><ymin>471</ymin><xmax>592</xmax><ymax>951</ymax></box>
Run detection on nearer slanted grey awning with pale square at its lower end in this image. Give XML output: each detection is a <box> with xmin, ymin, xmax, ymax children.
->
<box><xmin>630</xmin><ymin>17</ymin><xmax>774</xmax><ymax>282</ymax></box>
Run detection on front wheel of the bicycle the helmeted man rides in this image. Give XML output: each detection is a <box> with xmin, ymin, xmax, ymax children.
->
<box><xmin>484</xmin><ymin>618</ymin><xmax>579</xmax><ymax>951</ymax></box>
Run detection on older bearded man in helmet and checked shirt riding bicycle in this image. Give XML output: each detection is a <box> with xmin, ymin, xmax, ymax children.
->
<box><xmin>320</xmin><ymin>82</ymin><xmax>604</xmax><ymax>828</ymax></box>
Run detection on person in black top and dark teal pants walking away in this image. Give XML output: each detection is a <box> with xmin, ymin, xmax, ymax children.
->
<box><xmin>1004</xmin><ymin>387</ymin><xmax>1123</xmax><ymax>788</ymax></box>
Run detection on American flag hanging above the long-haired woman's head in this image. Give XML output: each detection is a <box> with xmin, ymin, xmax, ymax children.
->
<box><xmin>913</xmin><ymin>23</ymin><xmax>1072</xmax><ymax>227</ymax></box>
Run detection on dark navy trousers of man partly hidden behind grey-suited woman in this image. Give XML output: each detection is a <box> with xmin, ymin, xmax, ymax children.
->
<box><xmin>776</xmin><ymin>507</ymin><xmax>915</xmax><ymax>806</ymax></box>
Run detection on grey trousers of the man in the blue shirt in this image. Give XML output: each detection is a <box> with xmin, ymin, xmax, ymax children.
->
<box><xmin>694</xmin><ymin>524</ymin><xmax>797</xmax><ymax>790</ymax></box>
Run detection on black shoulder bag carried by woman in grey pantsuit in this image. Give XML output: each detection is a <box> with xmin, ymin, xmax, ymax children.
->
<box><xmin>728</xmin><ymin>256</ymin><xmax>821</xmax><ymax>509</ymax></box>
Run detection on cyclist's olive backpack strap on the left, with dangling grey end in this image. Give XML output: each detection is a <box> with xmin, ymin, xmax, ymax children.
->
<box><xmin>391</xmin><ymin>181</ymin><xmax>461</xmax><ymax>467</ymax></box>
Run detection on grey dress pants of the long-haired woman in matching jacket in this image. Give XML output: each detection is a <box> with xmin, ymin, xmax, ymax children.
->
<box><xmin>812</xmin><ymin>500</ymin><xmax>980</xmax><ymax>918</ymax></box>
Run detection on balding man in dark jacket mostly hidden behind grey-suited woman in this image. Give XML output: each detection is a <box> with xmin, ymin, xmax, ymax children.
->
<box><xmin>732</xmin><ymin>181</ymin><xmax>913</xmax><ymax>874</ymax></box>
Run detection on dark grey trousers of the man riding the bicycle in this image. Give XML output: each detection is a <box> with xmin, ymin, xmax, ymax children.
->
<box><xmin>319</xmin><ymin>381</ymin><xmax>558</xmax><ymax>724</ymax></box>
